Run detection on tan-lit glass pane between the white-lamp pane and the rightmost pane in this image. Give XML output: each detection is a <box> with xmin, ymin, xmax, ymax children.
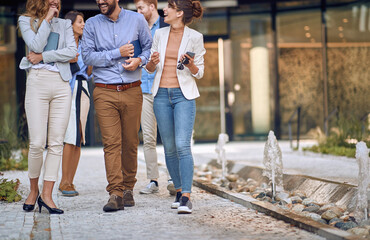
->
<box><xmin>277</xmin><ymin>8</ymin><xmax>323</xmax><ymax>136</ymax></box>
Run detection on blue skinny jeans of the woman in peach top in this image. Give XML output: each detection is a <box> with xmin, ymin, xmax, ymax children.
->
<box><xmin>153</xmin><ymin>88</ymin><xmax>195</xmax><ymax>193</ymax></box>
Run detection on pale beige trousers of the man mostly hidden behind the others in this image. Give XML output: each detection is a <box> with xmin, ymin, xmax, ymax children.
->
<box><xmin>141</xmin><ymin>93</ymin><xmax>159</xmax><ymax>179</ymax></box>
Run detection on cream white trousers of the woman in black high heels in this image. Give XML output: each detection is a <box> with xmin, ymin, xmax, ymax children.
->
<box><xmin>25</xmin><ymin>69</ymin><xmax>72</xmax><ymax>181</ymax></box>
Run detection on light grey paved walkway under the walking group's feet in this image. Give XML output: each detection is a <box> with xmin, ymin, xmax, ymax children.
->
<box><xmin>0</xmin><ymin>143</ymin><xmax>322</xmax><ymax>240</ymax></box>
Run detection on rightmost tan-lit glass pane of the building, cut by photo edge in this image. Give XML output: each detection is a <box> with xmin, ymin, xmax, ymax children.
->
<box><xmin>326</xmin><ymin>1</ymin><xmax>370</xmax><ymax>120</ymax></box>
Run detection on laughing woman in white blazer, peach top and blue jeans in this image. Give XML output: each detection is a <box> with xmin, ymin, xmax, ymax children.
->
<box><xmin>145</xmin><ymin>0</ymin><xmax>206</xmax><ymax>214</ymax></box>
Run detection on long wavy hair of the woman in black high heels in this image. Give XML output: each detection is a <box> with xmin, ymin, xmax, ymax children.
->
<box><xmin>23</xmin><ymin>0</ymin><xmax>61</xmax><ymax>32</ymax></box>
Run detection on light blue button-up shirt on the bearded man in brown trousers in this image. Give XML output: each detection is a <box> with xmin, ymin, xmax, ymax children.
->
<box><xmin>81</xmin><ymin>8</ymin><xmax>153</xmax><ymax>84</ymax></box>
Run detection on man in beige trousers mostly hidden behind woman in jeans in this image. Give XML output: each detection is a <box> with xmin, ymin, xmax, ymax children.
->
<box><xmin>134</xmin><ymin>0</ymin><xmax>176</xmax><ymax>194</ymax></box>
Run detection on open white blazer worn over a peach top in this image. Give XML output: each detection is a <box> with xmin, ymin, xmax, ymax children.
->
<box><xmin>145</xmin><ymin>26</ymin><xmax>206</xmax><ymax>100</ymax></box>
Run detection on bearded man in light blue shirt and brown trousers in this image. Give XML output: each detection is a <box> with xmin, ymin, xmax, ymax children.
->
<box><xmin>81</xmin><ymin>0</ymin><xmax>152</xmax><ymax>212</ymax></box>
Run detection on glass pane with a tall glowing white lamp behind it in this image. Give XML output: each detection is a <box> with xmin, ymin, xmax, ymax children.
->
<box><xmin>225</xmin><ymin>11</ymin><xmax>273</xmax><ymax>140</ymax></box>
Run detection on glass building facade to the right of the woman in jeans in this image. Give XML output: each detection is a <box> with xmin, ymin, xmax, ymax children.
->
<box><xmin>192</xmin><ymin>0</ymin><xmax>370</xmax><ymax>140</ymax></box>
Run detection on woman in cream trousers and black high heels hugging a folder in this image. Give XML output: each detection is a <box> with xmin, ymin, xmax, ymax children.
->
<box><xmin>18</xmin><ymin>0</ymin><xmax>77</xmax><ymax>214</ymax></box>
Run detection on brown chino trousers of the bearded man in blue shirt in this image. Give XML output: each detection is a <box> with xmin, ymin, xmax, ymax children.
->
<box><xmin>93</xmin><ymin>86</ymin><xmax>143</xmax><ymax>197</ymax></box>
